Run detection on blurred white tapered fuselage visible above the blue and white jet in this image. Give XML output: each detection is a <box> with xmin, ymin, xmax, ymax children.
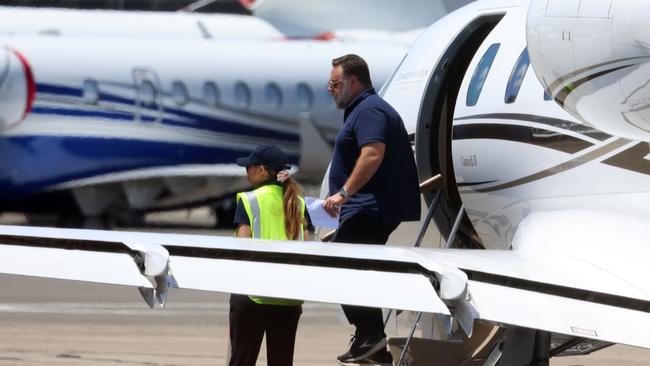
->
<box><xmin>0</xmin><ymin>6</ymin><xmax>285</xmax><ymax>40</ymax></box>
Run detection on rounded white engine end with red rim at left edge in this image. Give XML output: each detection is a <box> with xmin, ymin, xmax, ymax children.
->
<box><xmin>0</xmin><ymin>47</ymin><xmax>36</xmax><ymax>131</ymax></box>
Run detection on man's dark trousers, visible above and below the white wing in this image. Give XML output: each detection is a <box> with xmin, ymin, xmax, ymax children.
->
<box><xmin>332</xmin><ymin>213</ymin><xmax>399</xmax><ymax>338</ymax></box>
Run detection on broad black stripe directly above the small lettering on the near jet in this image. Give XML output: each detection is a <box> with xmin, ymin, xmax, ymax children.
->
<box><xmin>452</xmin><ymin>123</ymin><xmax>593</xmax><ymax>154</ymax></box>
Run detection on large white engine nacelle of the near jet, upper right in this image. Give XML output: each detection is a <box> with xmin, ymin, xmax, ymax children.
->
<box><xmin>526</xmin><ymin>0</ymin><xmax>650</xmax><ymax>141</ymax></box>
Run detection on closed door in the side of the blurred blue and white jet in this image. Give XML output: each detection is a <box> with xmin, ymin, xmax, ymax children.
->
<box><xmin>133</xmin><ymin>68</ymin><xmax>163</xmax><ymax>123</ymax></box>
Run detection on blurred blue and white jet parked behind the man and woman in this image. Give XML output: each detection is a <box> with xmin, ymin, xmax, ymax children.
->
<box><xmin>0</xmin><ymin>36</ymin><xmax>406</xmax><ymax>223</ymax></box>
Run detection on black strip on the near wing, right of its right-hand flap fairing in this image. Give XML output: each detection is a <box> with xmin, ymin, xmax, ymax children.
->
<box><xmin>461</xmin><ymin>268</ymin><xmax>650</xmax><ymax>313</ymax></box>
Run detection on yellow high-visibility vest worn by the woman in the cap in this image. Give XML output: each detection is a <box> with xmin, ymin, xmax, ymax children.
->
<box><xmin>237</xmin><ymin>184</ymin><xmax>305</xmax><ymax>305</ymax></box>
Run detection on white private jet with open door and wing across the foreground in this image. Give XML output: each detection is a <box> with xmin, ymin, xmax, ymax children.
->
<box><xmin>0</xmin><ymin>0</ymin><xmax>650</xmax><ymax>366</ymax></box>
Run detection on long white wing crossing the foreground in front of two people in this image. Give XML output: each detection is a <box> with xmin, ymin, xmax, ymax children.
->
<box><xmin>0</xmin><ymin>217</ymin><xmax>650</xmax><ymax>348</ymax></box>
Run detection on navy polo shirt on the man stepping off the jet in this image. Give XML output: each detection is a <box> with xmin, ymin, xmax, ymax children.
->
<box><xmin>329</xmin><ymin>88</ymin><xmax>420</xmax><ymax>223</ymax></box>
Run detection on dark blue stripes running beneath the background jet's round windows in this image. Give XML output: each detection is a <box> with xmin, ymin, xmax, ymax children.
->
<box><xmin>33</xmin><ymin>84</ymin><xmax>300</xmax><ymax>142</ymax></box>
